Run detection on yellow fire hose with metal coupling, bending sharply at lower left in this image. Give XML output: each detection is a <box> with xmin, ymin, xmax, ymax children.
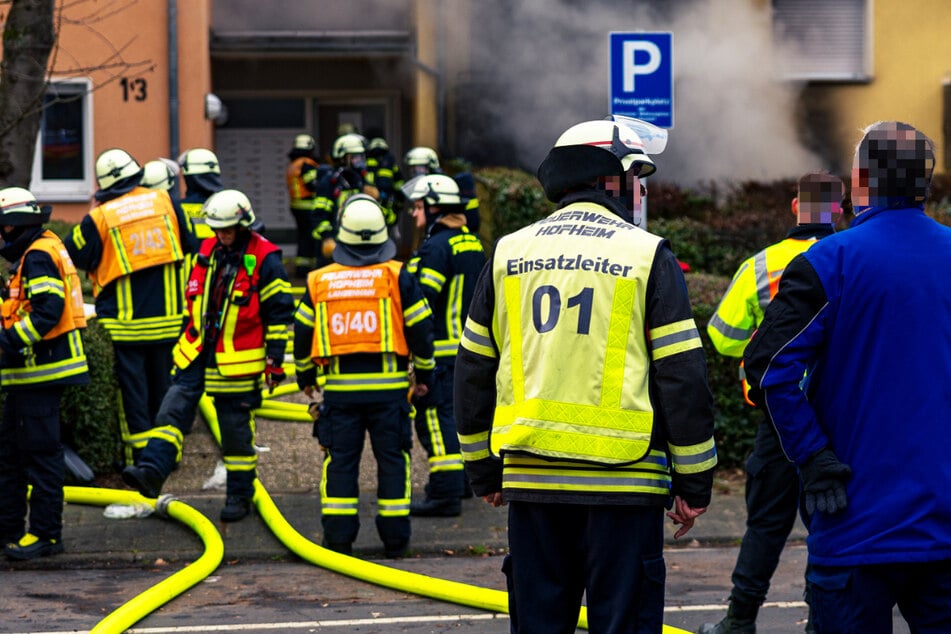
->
<box><xmin>63</xmin><ymin>486</ymin><xmax>225</xmax><ymax>634</ymax></box>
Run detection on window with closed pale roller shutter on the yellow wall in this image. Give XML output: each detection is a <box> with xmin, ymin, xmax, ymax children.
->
<box><xmin>772</xmin><ymin>0</ymin><xmax>872</xmax><ymax>81</ymax></box>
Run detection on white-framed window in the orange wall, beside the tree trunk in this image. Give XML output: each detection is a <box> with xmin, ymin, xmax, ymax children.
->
<box><xmin>30</xmin><ymin>79</ymin><xmax>95</xmax><ymax>202</ymax></box>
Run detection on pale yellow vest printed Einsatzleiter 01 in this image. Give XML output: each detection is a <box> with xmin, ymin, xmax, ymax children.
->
<box><xmin>491</xmin><ymin>202</ymin><xmax>660</xmax><ymax>465</ymax></box>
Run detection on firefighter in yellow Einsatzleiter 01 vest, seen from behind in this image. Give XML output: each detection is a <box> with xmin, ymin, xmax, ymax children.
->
<box><xmin>455</xmin><ymin>121</ymin><xmax>717</xmax><ymax>632</ymax></box>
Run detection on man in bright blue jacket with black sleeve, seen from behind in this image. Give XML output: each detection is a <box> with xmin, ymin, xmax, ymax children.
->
<box><xmin>744</xmin><ymin>121</ymin><xmax>951</xmax><ymax>633</ymax></box>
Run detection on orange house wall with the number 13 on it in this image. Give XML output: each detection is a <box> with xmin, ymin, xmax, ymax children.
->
<box><xmin>53</xmin><ymin>0</ymin><xmax>213</xmax><ymax>222</ymax></box>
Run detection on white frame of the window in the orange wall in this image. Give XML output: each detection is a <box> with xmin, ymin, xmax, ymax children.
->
<box><xmin>30</xmin><ymin>77</ymin><xmax>95</xmax><ymax>202</ymax></box>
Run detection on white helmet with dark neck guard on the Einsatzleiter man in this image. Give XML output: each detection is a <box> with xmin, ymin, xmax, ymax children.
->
<box><xmin>537</xmin><ymin>120</ymin><xmax>657</xmax><ymax>202</ymax></box>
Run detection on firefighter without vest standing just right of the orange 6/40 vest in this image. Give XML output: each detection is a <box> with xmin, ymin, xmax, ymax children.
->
<box><xmin>403</xmin><ymin>174</ymin><xmax>485</xmax><ymax>517</ymax></box>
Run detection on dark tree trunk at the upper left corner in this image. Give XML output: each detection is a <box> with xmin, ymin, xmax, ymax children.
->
<box><xmin>0</xmin><ymin>0</ymin><xmax>56</xmax><ymax>187</ymax></box>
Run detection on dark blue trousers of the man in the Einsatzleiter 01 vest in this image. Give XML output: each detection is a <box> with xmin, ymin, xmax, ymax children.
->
<box><xmin>502</xmin><ymin>502</ymin><xmax>666</xmax><ymax>634</ymax></box>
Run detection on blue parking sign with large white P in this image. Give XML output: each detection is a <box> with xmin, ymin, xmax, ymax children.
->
<box><xmin>609</xmin><ymin>32</ymin><xmax>674</xmax><ymax>128</ymax></box>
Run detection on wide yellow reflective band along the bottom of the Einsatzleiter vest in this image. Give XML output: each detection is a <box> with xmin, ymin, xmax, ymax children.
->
<box><xmin>492</xmin><ymin>398</ymin><xmax>654</xmax><ymax>464</ymax></box>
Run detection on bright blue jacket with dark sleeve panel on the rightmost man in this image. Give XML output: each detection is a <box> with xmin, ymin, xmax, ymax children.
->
<box><xmin>745</xmin><ymin>207</ymin><xmax>951</xmax><ymax>566</ymax></box>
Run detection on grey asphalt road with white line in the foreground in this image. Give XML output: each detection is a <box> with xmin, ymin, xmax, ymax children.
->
<box><xmin>0</xmin><ymin>545</ymin><xmax>908</xmax><ymax>634</ymax></box>
